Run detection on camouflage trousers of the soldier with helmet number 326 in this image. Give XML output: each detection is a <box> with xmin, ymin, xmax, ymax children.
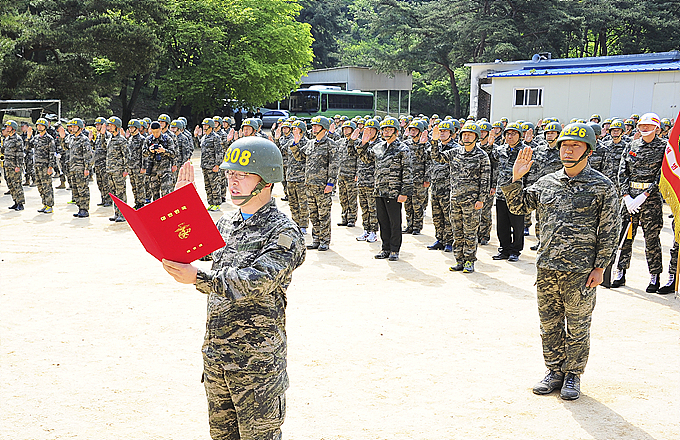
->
<box><xmin>536</xmin><ymin>267</ymin><xmax>595</xmax><ymax>374</ymax></box>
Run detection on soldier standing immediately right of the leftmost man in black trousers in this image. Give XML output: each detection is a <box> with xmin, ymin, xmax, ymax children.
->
<box><xmin>403</xmin><ymin>120</ymin><xmax>430</xmax><ymax>235</ymax></box>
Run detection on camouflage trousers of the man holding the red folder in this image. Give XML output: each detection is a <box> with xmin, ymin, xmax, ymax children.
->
<box><xmin>203</xmin><ymin>361</ymin><xmax>288</xmax><ymax>440</ymax></box>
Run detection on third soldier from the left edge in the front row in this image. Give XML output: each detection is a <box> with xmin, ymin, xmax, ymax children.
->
<box><xmin>67</xmin><ymin>118</ymin><xmax>93</xmax><ymax>218</ymax></box>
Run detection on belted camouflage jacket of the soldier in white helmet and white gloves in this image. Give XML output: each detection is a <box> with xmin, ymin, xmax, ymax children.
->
<box><xmin>619</xmin><ymin>136</ymin><xmax>666</xmax><ymax>198</ymax></box>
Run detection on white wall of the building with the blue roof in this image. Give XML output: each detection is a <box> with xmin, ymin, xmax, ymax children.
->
<box><xmin>491</xmin><ymin>71</ymin><xmax>680</xmax><ymax>122</ymax></box>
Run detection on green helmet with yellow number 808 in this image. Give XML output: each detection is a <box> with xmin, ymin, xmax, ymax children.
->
<box><xmin>220</xmin><ymin>136</ymin><xmax>283</xmax><ymax>183</ymax></box>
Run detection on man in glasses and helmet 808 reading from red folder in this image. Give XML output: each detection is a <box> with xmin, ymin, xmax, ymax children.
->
<box><xmin>163</xmin><ymin>137</ymin><xmax>305</xmax><ymax>440</ymax></box>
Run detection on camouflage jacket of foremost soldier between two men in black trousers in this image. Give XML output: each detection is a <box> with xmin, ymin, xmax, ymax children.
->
<box><xmin>431</xmin><ymin>143</ymin><xmax>491</xmax><ymax>203</ymax></box>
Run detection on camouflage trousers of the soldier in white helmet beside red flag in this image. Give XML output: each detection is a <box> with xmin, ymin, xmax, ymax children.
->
<box><xmin>618</xmin><ymin>193</ymin><xmax>663</xmax><ymax>274</ymax></box>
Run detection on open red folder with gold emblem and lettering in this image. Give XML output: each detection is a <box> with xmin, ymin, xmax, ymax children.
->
<box><xmin>111</xmin><ymin>184</ymin><xmax>225</xmax><ymax>263</ymax></box>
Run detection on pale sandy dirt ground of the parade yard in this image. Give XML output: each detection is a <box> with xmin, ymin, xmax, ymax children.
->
<box><xmin>0</xmin><ymin>153</ymin><xmax>680</xmax><ymax>440</ymax></box>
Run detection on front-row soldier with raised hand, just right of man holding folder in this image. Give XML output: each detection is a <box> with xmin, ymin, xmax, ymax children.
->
<box><xmin>290</xmin><ymin>116</ymin><xmax>340</xmax><ymax>251</ymax></box>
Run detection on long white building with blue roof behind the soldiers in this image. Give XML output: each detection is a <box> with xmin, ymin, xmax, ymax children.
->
<box><xmin>466</xmin><ymin>51</ymin><xmax>680</xmax><ymax>122</ymax></box>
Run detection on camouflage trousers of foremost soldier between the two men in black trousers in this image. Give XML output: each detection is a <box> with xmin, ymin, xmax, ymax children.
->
<box><xmin>450</xmin><ymin>197</ymin><xmax>481</xmax><ymax>263</ymax></box>
